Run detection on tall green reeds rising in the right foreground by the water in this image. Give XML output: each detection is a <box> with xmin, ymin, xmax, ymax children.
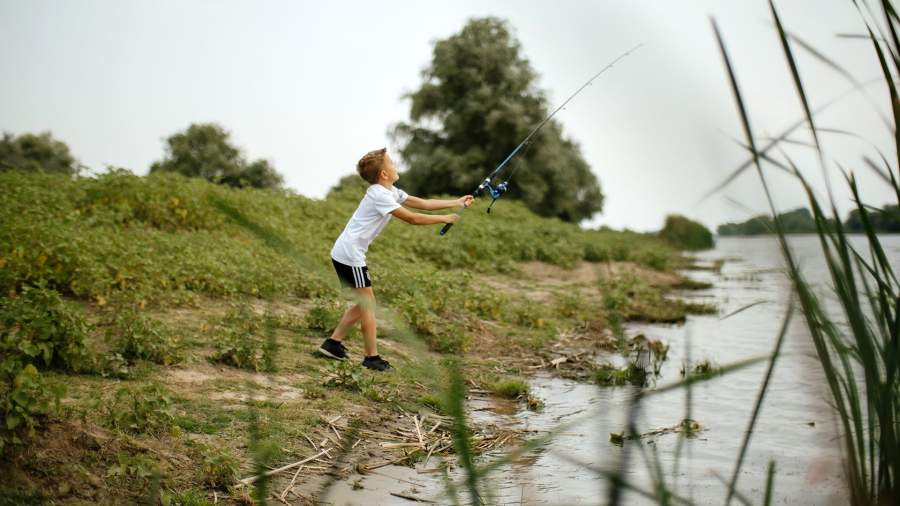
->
<box><xmin>713</xmin><ymin>0</ymin><xmax>900</xmax><ymax>505</ymax></box>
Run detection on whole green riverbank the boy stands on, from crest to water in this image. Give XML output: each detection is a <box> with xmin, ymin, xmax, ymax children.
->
<box><xmin>0</xmin><ymin>171</ymin><xmax>716</xmax><ymax>504</ymax></box>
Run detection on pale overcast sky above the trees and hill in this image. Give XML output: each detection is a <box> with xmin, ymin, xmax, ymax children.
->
<box><xmin>0</xmin><ymin>0</ymin><xmax>896</xmax><ymax>231</ymax></box>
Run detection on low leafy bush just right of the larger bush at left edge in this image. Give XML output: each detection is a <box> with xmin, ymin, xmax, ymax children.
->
<box><xmin>107</xmin><ymin>309</ymin><xmax>183</xmax><ymax>365</ymax></box>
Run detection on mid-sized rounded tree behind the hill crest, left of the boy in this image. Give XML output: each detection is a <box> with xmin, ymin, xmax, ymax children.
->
<box><xmin>150</xmin><ymin>123</ymin><xmax>284</xmax><ymax>188</ymax></box>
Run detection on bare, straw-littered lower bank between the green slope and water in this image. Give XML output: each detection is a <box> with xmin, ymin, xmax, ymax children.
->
<box><xmin>4</xmin><ymin>262</ymin><xmax>712</xmax><ymax>503</ymax></box>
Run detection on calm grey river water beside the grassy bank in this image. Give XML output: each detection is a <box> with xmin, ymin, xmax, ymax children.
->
<box><xmin>326</xmin><ymin>235</ymin><xmax>900</xmax><ymax>505</ymax></box>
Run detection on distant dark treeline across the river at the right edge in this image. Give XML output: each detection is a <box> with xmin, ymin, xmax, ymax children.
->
<box><xmin>717</xmin><ymin>205</ymin><xmax>900</xmax><ymax>235</ymax></box>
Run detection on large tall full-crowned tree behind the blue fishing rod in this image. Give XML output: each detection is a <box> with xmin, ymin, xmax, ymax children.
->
<box><xmin>391</xmin><ymin>17</ymin><xmax>603</xmax><ymax>222</ymax></box>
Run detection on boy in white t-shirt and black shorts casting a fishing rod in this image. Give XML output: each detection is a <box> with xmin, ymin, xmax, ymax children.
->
<box><xmin>319</xmin><ymin>148</ymin><xmax>473</xmax><ymax>371</ymax></box>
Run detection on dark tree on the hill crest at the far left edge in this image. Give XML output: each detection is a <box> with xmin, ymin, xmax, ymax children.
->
<box><xmin>0</xmin><ymin>132</ymin><xmax>80</xmax><ymax>174</ymax></box>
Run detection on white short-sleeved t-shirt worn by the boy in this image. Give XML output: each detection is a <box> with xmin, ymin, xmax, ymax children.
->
<box><xmin>331</xmin><ymin>184</ymin><xmax>408</xmax><ymax>267</ymax></box>
